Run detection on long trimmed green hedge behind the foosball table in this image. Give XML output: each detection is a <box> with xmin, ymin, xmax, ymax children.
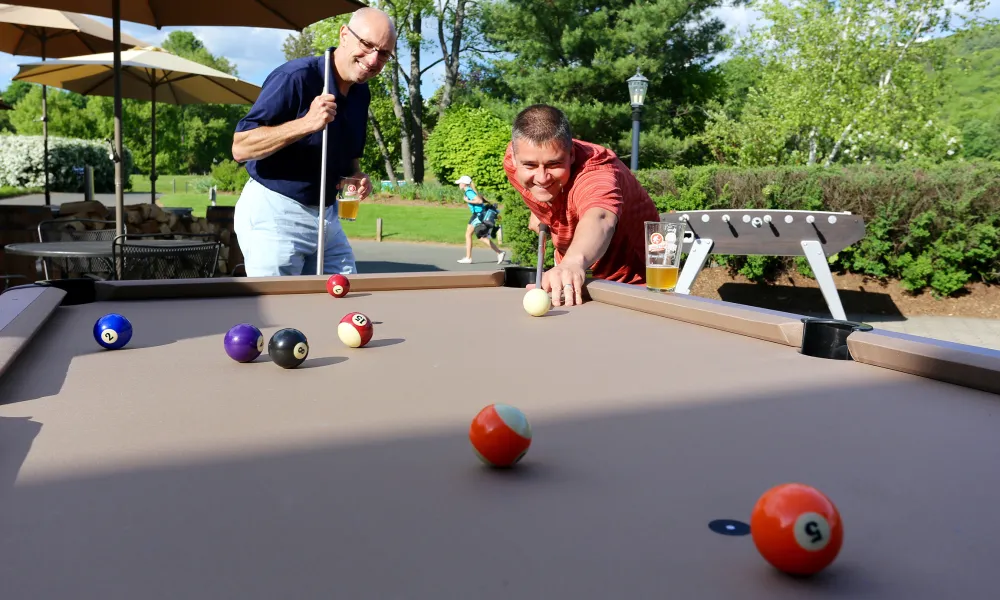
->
<box><xmin>504</xmin><ymin>162</ymin><xmax>1000</xmax><ymax>296</ymax></box>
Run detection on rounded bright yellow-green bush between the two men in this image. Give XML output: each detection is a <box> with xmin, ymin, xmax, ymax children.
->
<box><xmin>424</xmin><ymin>106</ymin><xmax>511</xmax><ymax>194</ymax></box>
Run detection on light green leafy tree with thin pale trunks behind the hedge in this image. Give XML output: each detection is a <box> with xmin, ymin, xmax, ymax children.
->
<box><xmin>704</xmin><ymin>0</ymin><xmax>984</xmax><ymax>165</ymax></box>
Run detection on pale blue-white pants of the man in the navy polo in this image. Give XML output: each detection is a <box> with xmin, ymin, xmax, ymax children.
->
<box><xmin>233</xmin><ymin>178</ymin><xmax>357</xmax><ymax>277</ymax></box>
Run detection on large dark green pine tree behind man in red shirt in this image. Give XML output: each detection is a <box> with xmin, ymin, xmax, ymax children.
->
<box><xmin>472</xmin><ymin>0</ymin><xmax>729</xmax><ymax>166</ymax></box>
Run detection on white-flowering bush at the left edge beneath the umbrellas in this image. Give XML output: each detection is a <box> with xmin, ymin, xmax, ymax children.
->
<box><xmin>0</xmin><ymin>135</ymin><xmax>133</xmax><ymax>194</ymax></box>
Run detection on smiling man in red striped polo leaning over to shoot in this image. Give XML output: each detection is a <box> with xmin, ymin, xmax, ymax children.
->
<box><xmin>503</xmin><ymin>104</ymin><xmax>660</xmax><ymax>306</ymax></box>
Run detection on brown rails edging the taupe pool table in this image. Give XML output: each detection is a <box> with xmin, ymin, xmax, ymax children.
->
<box><xmin>0</xmin><ymin>268</ymin><xmax>1000</xmax><ymax>394</ymax></box>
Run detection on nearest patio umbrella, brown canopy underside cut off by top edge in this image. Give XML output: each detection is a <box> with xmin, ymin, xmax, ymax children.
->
<box><xmin>5</xmin><ymin>0</ymin><xmax>365</xmax><ymax>235</ymax></box>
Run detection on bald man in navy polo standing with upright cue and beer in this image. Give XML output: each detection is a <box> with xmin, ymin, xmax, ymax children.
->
<box><xmin>233</xmin><ymin>8</ymin><xmax>396</xmax><ymax>277</ymax></box>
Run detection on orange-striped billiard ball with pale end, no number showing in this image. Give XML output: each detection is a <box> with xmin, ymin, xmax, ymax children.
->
<box><xmin>469</xmin><ymin>404</ymin><xmax>531</xmax><ymax>468</ymax></box>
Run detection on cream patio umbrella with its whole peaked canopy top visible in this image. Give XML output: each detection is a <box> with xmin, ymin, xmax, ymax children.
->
<box><xmin>13</xmin><ymin>46</ymin><xmax>260</xmax><ymax>203</ymax></box>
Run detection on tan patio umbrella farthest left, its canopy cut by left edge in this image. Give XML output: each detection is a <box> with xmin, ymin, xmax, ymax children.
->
<box><xmin>0</xmin><ymin>4</ymin><xmax>148</xmax><ymax>206</ymax></box>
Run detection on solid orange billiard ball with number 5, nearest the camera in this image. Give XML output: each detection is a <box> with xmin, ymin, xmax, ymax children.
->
<box><xmin>750</xmin><ymin>483</ymin><xmax>844</xmax><ymax>575</ymax></box>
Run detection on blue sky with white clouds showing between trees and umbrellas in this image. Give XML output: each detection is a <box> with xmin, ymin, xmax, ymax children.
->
<box><xmin>0</xmin><ymin>0</ymin><xmax>1000</xmax><ymax>97</ymax></box>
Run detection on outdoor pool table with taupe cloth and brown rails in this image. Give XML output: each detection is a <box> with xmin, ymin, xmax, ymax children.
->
<box><xmin>0</xmin><ymin>269</ymin><xmax>1000</xmax><ymax>600</ymax></box>
